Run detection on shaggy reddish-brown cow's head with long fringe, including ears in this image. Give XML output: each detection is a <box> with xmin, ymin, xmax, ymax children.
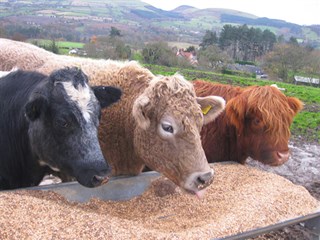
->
<box><xmin>226</xmin><ymin>86</ymin><xmax>302</xmax><ymax>166</ymax></box>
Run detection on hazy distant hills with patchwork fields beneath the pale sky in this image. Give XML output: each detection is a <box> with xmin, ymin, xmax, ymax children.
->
<box><xmin>0</xmin><ymin>0</ymin><xmax>320</xmax><ymax>47</ymax></box>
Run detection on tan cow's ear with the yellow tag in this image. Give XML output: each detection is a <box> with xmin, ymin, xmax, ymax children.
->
<box><xmin>197</xmin><ymin>96</ymin><xmax>226</xmax><ymax>125</ymax></box>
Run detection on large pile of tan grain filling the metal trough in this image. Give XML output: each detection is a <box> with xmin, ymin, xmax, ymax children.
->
<box><xmin>0</xmin><ymin>164</ymin><xmax>319</xmax><ymax>239</ymax></box>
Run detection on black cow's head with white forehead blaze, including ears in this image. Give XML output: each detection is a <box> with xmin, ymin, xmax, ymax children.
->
<box><xmin>25</xmin><ymin>68</ymin><xmax>121</xmax><ymax>187</ymax></box>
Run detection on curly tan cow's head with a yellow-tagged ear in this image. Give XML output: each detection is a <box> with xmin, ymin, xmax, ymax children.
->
<box><xmin>133</xmin><ymin>75</ymin><xmax>225</xmax><ymax>194</ymax></box>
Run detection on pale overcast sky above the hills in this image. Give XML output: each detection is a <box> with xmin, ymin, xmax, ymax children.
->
<box><xmin>142</xmin><ymin>0</ymin><xmax>320</xmax><ymax>25</ymax></box>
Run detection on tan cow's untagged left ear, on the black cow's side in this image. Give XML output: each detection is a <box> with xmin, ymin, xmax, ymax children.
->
<box><xmin>132</xmin><ymin>95</ymin><xmax>150</xmax><ymax>130</ymax></box>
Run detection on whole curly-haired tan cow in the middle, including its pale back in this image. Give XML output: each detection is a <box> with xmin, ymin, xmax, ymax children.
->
<box><xmin>0</xmin><ymin>39</ymin><xmax>224</xmax><ymax>193</ymax></box>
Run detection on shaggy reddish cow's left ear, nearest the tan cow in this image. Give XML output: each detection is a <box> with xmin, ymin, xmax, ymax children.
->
<box><xmin>226</xmin><ymin>96</ymin><xmax>247</xmax><ymax>134</ymax></box>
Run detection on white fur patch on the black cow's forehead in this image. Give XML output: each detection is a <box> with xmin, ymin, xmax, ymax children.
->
<box><xmin>62</xmin><ymin>82</ymin><xmax>91</xmax><ymax>122</ymax></box>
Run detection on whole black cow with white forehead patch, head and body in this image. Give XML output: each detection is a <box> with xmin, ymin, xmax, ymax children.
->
<box><xmin>0</xmin><ymin>68</ymin><xmax>121</xmax><ymax>190</ymax></box>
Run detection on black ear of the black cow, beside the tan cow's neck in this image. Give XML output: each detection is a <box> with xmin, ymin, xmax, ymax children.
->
<box><xmin>92</xmin><ymin>86</ymin><xmax>122</xmax><ymax>108</ymax></box>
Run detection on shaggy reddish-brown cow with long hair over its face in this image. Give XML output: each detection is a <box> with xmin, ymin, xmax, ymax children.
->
<box><xmin>193</xmin><ymin>80</ymin><xmax>302</xmax><ymax>165</ymax></box>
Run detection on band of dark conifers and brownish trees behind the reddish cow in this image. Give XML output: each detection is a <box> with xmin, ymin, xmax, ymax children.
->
<box><xmin>198</xmin><ymin>24</ymin><xmax>320</xmax><ymax>82</ymax></box>
